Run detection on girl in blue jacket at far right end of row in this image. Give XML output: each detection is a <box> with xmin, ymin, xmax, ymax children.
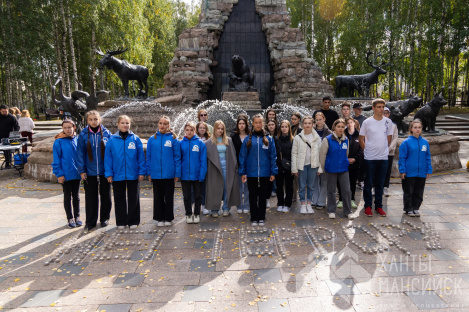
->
<box><xmin>398</xmin><ymin>119</ymin><xmax>433</xmax><ymax>217</ymax></box>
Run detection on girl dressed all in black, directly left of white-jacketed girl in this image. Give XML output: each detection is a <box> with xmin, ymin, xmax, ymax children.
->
<box><xmin>275</xmin><ymin>120</ymin><xmax>293</xmax><ymax>212</ymax></box>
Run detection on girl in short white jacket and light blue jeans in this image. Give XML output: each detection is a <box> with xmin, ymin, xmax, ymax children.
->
<box><xmin>291</xmin><ymin>116</ymin><xmax>322</xmax><ymax>214</ymax></box>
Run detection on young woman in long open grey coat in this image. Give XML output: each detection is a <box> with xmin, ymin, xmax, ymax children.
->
<box><xmin>205</xmin><ymin>120</ymin><xmax>240</xmax><ymax>218</ymax></box>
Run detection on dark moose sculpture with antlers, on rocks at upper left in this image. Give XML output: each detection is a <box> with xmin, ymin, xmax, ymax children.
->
<box><xmin>96</xmin><ymin>48</ymin><xmax>149</xmax><ymax>97</ymax></box>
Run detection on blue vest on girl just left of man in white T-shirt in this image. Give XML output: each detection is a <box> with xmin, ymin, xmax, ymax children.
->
<box><xmin>321</xmin><ymin>133</ymin><xmax>350</xmax><ymax>173</ymax></box>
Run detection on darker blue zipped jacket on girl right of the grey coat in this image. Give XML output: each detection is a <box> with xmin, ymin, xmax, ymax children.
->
<box><xmin>239</xmin><ymin>133</ymin><xmax>278</xmax><ymax>178</ymax></box>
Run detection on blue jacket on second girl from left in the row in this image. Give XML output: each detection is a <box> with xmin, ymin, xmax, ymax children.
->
<box><xmin>77</xmin><ymin>125</ymin><xmax>111</xmax><ymax>176</ymax></box>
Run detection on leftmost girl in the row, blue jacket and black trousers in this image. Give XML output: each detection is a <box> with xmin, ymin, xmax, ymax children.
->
<box><xmin>52</xmin><ymin>119</ymin><xmax>83</xmax><ymax>228</ymax></box>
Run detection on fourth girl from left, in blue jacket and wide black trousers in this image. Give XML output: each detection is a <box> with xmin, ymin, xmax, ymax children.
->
<box><xmin>147</xmin><ymin>116</ymin><xmax>181</xmax><ymax>226</ymax></box>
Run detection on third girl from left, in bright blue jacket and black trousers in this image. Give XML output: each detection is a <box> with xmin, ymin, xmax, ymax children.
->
<box><xmin>104</xmin><ymin>115</ymin><xmax>146</xmax><ymax>229</ymax></box>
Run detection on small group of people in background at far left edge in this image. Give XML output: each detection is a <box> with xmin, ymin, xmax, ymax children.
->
<box><xmin>0</xmin><ymin>104</ymin><xmax>35</xmax><ymax>169</ymax></box>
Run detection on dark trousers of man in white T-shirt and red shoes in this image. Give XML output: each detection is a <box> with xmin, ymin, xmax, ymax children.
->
<box><xmin>363</xmin><ymin>159</ymin><xmax>388</xmax><ymax>209</ymax></box>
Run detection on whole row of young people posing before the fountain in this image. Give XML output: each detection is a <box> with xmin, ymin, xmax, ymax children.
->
<box><xmin>52</xmin><ymin>97</ymin><xmax>432</xmax><ymax>231</ymax></box>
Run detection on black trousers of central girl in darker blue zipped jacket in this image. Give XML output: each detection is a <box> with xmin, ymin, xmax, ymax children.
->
<box><xmin>248</xmin><ymin>177</ymin><xmax>272</xmax><ymax>222</ymax></box>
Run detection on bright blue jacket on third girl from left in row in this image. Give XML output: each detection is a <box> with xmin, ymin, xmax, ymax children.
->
<box><xmin>104</xmin><ymin>131</ymin><xmax>146</xmax><ymax>181</ymax></box>
